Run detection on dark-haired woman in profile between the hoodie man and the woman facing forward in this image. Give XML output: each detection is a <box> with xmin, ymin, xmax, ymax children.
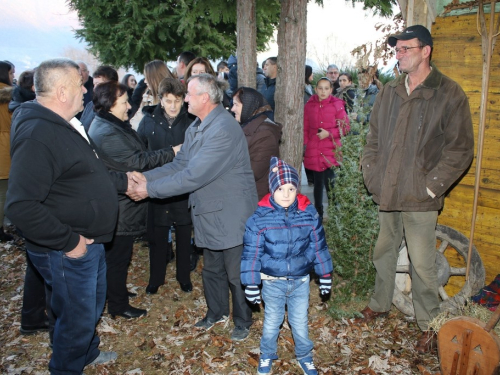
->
<box><xmin>89</xmin><ymin>81</ymin><xmax>175</xmax><ymax>319</ymax></box>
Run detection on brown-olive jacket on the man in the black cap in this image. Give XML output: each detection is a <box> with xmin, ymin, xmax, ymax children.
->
<box><xmin>362</xmin><ymin>64</ymin><xmax>474</xmax><ymax>211</ymax></box>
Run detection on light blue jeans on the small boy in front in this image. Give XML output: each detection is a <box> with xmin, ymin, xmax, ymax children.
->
<box><xmin>260</xmin><ymin>275</ymin><xmax>313</xmax><ymax>359</ymax></box>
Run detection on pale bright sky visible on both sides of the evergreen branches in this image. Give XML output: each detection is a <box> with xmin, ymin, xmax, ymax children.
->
<box><xmin>0</xmin><ymin>0</ymin><xmax>390</xmax><ymax>76</ymax></box>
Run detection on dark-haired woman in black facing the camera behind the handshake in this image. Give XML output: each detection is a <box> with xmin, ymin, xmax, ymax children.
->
<box><xmin>137</xmin><ymin>78</ymin><xmax>194</xmax><ymax>294</ymax></box>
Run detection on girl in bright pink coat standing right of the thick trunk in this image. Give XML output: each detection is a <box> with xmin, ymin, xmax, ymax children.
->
<box><xmin>304</xmin><ymin>77</ymin><xmax>350</xmax><ymax>222</ymax></box>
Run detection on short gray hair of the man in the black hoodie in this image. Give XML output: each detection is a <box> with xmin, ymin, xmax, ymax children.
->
<box><xmin>34</xmin><ymin>58</ymin><xmax>80</xmax><ymax>97</ymax></box>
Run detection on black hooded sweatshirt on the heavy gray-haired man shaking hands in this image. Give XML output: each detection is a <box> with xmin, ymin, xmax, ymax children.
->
<box><xmin>5</xmin><ymin>102</ymin><xmax>127</xmax><ymax>252</ymax></box>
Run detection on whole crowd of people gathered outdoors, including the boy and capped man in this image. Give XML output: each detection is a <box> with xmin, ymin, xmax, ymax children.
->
<box><xmin>0</xmin><ymin>25</ymin><xmax>473</xmax><ymax>374</ymax></box>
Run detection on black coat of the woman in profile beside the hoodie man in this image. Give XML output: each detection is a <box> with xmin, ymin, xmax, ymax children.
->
<box><xmin>89</xmin><ymin>113</ymin><xmax>174</xmax><ymax>236</ymax></box>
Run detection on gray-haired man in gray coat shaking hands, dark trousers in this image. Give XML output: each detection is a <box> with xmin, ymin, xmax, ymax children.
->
<box><xmin>129</xmin><ymin>74</ymin><xmax>257</xmax><ymax>340</ymax></box>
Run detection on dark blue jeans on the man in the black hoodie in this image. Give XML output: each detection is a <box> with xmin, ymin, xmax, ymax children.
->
<box><xmin>28</xmin><ymin>244</ymin><xmax>106</xmax><ymax>375</ymax></box>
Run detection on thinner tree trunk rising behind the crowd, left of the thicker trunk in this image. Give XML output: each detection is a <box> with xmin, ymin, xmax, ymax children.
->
<box><xmin>236</xmin><ymin>0</ymin><xmax>257</xmax><ymax>87</ymax></box>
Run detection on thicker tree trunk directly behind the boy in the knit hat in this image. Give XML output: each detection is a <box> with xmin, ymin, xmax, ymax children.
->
<box><xmin>274</xmin><ymin>0</ymin><xmax>307</xmax><ymax>171</ymax></box>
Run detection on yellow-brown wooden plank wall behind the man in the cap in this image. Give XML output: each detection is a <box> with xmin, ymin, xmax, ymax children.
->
<box><xmin>432</xmin><ymin>15</ymin><xmax>500</xmax><ymax>291</ymax></box>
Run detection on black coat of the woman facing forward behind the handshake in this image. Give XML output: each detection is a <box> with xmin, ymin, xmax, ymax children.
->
<box><xmin>137</xmin><ymin>104</ymin><xmax>195</xmax><ymax>226</ymax></box>
